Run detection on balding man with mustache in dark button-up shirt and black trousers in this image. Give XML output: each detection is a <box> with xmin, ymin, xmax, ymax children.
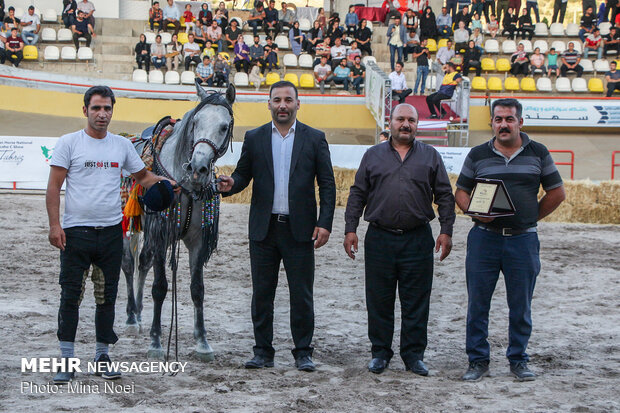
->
<box><xmin>344</xmin><ymin>104</ymin><xmax>455</xmax><ymax>376</ymax></box>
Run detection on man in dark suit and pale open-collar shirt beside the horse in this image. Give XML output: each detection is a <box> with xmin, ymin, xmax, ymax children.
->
<box><xmin>218</xmin><ymin>81</ymin><xmax>336</xmax><ymax>371</ymax></box>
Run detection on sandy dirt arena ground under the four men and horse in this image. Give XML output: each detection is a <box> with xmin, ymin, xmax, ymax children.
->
<box><xmin>0</xmin><ymin>194</ymin><xmax>620</xmax><ymax>413</ymax></box>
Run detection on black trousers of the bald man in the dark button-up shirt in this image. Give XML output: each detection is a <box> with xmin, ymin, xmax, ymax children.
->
<box><xmin>364</xmin><ymin>224</ymin><xmax>434</xmax><ymax>364</ymax></box>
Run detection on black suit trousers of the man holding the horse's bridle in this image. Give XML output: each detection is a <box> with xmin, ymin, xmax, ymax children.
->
<box><xmin>250</xmin><ymin>217</ymin><xmax>314</xmax><ymax>359</ymax></box>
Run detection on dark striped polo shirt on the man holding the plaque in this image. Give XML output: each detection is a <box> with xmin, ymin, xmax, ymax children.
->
<box><xmin>456</xmin><ymin>132</ymin><xmax>562</xmax><ymax>229</ymax></box>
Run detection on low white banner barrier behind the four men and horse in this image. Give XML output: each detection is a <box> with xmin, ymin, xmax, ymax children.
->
<box><xmin>0</xmin><ymin>136</ymin><xmax>470</xmax><ymax>189</ymax></box>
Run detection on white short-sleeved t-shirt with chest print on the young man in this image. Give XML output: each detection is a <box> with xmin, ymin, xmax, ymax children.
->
<box><xmin>51</xmin><ymin>130</ymin><xmax>144</xmax><ymax>228</ymax></box>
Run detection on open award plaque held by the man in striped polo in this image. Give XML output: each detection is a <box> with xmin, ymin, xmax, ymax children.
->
<box><xmin>465</xmin><ymin>178</ymin><xmax>515</xmax><ymax>217</ymax></box>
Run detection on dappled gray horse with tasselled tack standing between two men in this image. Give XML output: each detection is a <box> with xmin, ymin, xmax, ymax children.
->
<box><xmin>122</xmin><ymin>85</ymin><xmax>235</xmax><ymax>361</ymax></box>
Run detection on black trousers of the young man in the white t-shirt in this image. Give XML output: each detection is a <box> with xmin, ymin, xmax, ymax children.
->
<box><xmin>57</xmin><ymin>223</ymin><xmax>123</xmax><ymax>344</ymax></box>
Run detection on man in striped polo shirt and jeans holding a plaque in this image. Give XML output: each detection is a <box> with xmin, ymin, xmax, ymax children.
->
<box><xmin>455</xmin><ymin>99</ymin><xmax>565</xmax><ymax>381</ymax></box>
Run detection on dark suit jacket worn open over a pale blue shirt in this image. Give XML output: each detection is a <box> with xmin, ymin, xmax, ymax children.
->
<box><xmin>223</xmin><ymin>121</ymin><xmax>336</xmax><ymax>242</ymax></box>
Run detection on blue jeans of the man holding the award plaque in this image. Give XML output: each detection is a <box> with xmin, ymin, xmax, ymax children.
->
<box><xmin>465</xmin><ymin>227</ymin><xmax>540</xmax><ymax>362</ymax></box>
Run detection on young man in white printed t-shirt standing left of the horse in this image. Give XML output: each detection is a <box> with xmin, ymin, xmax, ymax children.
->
<box><xmin>45</xmin><ymin>86</ymin><xmax>178</xmax><ymax>384</ymax></box>
